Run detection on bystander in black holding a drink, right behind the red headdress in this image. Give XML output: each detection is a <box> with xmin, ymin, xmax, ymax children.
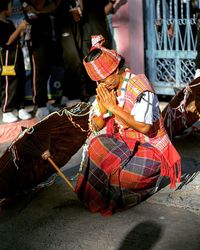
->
<box><xmin>56</xmin><ymin>0</ymin><xmax>114</xmax><ymax>104</ymax></box>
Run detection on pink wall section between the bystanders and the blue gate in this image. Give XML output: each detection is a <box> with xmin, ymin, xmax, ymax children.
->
<box><xmin>112</xmin><ymin>0</ymin><xmax>144</xmax><ymax>74</ymax></box>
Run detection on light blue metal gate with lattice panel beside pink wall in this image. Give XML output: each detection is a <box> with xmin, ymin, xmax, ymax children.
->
<box><xmin>144</xmin><ymin>0</ymin><xmax>200</xmax><ymax>95</ymax></box>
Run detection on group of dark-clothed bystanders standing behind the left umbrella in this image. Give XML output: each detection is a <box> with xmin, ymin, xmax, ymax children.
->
<box><xmin>0</xmin><ymin>0</ymin><xmax>116</xmax><ymax>123</ymax></box>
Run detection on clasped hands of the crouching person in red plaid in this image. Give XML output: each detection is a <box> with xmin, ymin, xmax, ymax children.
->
<box><xmin>96</xmin><ymin>83</ymin><xmax>117</xmax><ymax>114</ymax></box>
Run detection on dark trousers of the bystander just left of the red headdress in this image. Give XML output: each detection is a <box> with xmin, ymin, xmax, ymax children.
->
<box><xmin>61</xmin><ymin>21</ymin><xmax>94</xmax><ymax>101</ymax></box>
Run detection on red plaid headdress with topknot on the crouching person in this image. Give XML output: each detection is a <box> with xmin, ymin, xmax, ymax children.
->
<box><xmin>83</xmin><ymin>35</ymin><xmax>122</xmax><ymax>81</ymax></box>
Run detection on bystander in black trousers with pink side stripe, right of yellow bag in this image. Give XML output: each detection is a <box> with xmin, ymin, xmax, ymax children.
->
<box><xmin>22</xmin><ymin>0</ymin><xmax>56</xmax><ymax>120</ymax></box>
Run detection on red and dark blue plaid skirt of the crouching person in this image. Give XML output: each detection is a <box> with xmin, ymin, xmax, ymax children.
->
<box><xmin>75</xmin><ymin>135</ymin><xmax>161</xmax><ymax>215</ymax></box>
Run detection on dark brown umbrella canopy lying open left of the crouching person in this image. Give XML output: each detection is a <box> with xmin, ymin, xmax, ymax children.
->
<box><xmin>0</xmin><ymin>103</ymin><xmax>90</xmax><ymax>198</ymax></box>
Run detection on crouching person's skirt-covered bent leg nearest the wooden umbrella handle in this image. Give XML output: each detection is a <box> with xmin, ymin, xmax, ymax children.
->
<box><xmin>76</xmin><ymin>135</ymin><xmax>134</xmax><ymax>215</ymax></box>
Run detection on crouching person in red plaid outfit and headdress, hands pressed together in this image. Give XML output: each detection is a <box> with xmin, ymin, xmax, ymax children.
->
<box><xmin>76</xmin><ymin>35</ymin><xmax>181</xmax><ymax>215</ymax></box>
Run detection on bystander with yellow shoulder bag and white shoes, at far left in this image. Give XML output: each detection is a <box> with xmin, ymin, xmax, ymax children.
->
<box><xmin>0</xmin><ymin>0</ymin><xmax>31</xmax><ymax>123</ymax></box>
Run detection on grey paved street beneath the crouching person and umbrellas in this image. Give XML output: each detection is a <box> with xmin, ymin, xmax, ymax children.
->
<box><xmin>0</xmin><ymin>100</ymin><xmax>200</xmax><ymax>250</ymax></box>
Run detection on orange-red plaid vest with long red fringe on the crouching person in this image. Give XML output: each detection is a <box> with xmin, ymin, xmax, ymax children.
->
<box><xmin>107</xmin><ymin>74</ymin><xmax>181</xmax><ymax>188</ymax></box>
